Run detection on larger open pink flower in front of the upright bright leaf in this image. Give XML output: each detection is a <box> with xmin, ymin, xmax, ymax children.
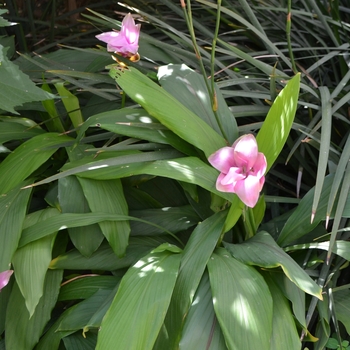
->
<box><xmin>208</xmin><ymin>134</ymin><xmax>267</xmax><ymax>208</ymax></box>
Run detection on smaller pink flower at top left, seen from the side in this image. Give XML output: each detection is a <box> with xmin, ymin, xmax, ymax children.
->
<box><xmin>96</xmin><ymin>13</ymin><xmax>141</xmax><ymax>57</ymax></box>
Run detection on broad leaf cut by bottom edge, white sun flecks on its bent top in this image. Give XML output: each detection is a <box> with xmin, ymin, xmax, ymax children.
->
<box><xmin>96</xmin><ymin>247</ymin><xmax>181</xmax><ymax>350</ymax></box>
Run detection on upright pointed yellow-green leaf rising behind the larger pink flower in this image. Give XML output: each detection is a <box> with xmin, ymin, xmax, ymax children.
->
<box><xmin>256</xmin><ymin>74</ymin><xmax>300</xmax><ymax>171</ymax></box>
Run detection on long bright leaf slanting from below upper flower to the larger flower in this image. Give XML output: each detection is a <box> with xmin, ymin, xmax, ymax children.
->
<box><xmin>110</xmin><ymin>65</ymin><xmax>226</xmax><ymax>157</ymax></box>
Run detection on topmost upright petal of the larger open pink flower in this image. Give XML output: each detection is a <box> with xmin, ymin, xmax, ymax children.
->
<box><xmin>232</xmin><ymin>134</ymin><xmax>258</xmax><ymax>169</ymax></box>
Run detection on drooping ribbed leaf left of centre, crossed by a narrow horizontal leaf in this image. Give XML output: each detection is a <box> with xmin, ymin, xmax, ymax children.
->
<box><xmin>79</xmin><ymin>178</ymin><xmax>130</xmax><ymax>256</ymax></box>
